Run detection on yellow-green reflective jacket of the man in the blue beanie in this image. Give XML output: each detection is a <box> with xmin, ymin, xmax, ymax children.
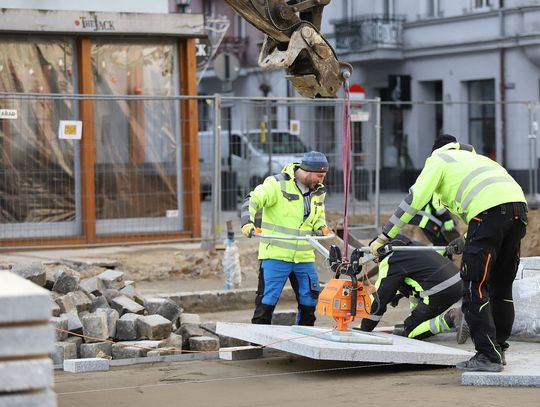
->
<box><xmin>249</xmin><ymin>164</ymin><xmax>326</xmax><ymax>263</ymax></box>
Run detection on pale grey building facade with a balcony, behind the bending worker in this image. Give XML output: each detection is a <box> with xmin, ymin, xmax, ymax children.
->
<box><xmin>200</xmin><ymin>0</ymin><xmax>540</xmax><ymax>190</ymax></box>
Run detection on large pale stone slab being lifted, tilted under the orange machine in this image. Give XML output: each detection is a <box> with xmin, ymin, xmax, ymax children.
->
<box><xmin>216</xmin><ymin>322</ymin><xmax>472</xmax><ymax>366</ymax></box>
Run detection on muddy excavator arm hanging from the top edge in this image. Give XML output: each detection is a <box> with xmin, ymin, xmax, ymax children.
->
<box><xmin>225</xmin><ymin>0</ymin><xmax>352</xmax><ymax>98</ymax></box>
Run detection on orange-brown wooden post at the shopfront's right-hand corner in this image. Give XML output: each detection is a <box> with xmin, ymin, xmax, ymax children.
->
<box><xmin>178</xmin><ymin>38</ymin><xmax>201</xmax><ymax>237</ymax></box>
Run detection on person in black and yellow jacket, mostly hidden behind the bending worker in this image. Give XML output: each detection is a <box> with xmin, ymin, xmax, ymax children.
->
<box><xmin>409</xmin><ymin>194</ymin><xmax>459</xmax><ymax>246</ymax></box>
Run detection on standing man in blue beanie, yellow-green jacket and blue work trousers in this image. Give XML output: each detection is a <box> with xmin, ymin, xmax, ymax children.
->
<box><xmin>241</xmin><ymin>151</ymin><xmax>329</xmax><ymax>325</ymax></box>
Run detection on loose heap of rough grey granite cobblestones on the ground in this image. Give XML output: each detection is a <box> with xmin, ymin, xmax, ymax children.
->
<box><xmin>7</xmin><ymin>263</ymin><xmax>245</xmax><ymax>367</ymax></box>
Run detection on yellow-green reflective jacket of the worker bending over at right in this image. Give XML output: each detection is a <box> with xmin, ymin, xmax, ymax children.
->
<box><xmin>383</xmin><ymin>143</ymin><xmax>527</xmax><ymax>238</ymax></box>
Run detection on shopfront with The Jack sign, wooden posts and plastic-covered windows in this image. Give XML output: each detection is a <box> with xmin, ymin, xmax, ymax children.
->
<box><xmin>0</xmin><ymin>0</ymin><xmax>204</xmax><ymax>246</ymax></box>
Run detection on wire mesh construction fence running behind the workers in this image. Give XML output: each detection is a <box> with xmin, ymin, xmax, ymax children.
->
<box><xmin>0</xmin><ymin>94</ymin><xmax>540</xmax><ymax>249</ymax></box>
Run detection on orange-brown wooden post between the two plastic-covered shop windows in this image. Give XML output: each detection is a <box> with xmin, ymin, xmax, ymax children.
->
<box><xmin>77</xmin><ymin>37</ymin><xmax>96</xmax><ymax>243</ymax></box>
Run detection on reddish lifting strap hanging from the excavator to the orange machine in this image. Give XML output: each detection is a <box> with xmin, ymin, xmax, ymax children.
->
<box><xmin>343</xmin><ymin>80</ymin><xmax>351</xmax><ymax>258</ymax></box>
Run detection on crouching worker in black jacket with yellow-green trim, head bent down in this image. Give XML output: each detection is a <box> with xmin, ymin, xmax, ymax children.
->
<box><xmin>360</xmin><ymin>235</ymin><xmax>468</xmax><ymax>343</ymax></box>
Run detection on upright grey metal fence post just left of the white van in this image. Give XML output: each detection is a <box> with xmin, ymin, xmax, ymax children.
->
<box><xmin>212</xmin><ymin>93</ymin><xmax>221</xmax><ymax>247</ymax></box>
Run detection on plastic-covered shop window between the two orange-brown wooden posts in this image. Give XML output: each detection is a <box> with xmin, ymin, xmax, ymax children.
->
<box><xmin>92</xmin><ymin>39</ymin><xmax>180</xmax><ymax>220</ymax></box>
